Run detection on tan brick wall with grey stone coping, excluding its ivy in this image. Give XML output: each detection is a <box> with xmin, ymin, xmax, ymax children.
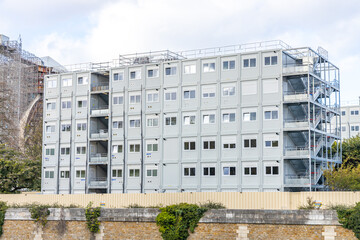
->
<box><xmin>0</xmin><ymin>208</ymin><xmax>356</xmax><ymax>240</ymax></box>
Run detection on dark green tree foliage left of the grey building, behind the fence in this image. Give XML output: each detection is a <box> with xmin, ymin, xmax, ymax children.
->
<box><xmin>0</xmin><ymin>145</ymin><xmax>41</xmax><ymax>193</ymax></box>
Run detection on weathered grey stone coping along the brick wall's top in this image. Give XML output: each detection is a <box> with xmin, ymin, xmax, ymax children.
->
<box><xmin>5</xmin><ymin>208</ymin><xmax>340</xmax><ymax>225</ymax></box>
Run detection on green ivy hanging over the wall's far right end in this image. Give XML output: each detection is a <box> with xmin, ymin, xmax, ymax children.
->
<box><xmin>336</xmin><ymin>202</ymin><xmax>360</xmax><ymax>239</ymax></box>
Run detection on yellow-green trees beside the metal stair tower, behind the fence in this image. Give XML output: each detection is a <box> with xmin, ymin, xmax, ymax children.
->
<box><xmin>324</xmin><ymin>135</ymin><xmax>360</xmax><ymax>191</ymax></box>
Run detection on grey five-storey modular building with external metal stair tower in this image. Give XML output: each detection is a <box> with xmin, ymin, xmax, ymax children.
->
<box><xmin>42</xmin><ymin>41</ymin><xmax>341</xmax><ymax>193</ymax></box>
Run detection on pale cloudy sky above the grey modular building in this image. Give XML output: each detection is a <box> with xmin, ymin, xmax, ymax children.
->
<box><xmin>0</xmin><ymin>0</ymin><xmax>360</xmax><ymax>102</ymax></box>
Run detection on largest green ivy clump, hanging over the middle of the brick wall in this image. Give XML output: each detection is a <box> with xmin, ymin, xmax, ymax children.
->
<box><xmin>156</xmin><ymin>203</ymin><xmax>207</xmax><ymax>240</ymax></box>
